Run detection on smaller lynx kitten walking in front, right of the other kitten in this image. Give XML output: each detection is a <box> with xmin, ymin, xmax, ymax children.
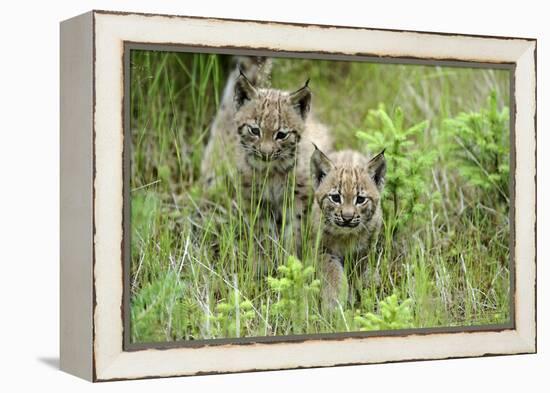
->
<box><xmin>311</xmin><ymin>145</ymin><xmax>386</xmax><ymax>305</ymax></box>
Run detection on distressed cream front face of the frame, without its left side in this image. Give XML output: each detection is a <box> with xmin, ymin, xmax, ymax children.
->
<box><xmin>61</xmin><ymin>12</ymin><xmax>536</xmax><ymax>380</ymax></box>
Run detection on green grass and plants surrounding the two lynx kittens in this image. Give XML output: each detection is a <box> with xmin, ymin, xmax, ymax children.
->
<box><xmin>130</xmin><ymin>51</ymin><xmax>510</xmax><ymax>342</ymax></box>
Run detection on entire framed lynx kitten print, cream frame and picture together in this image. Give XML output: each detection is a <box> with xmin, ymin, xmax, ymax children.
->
<box><xmin>60</xmin><ymin>11</ymin><xmax>536</xmax><ymax>381</ymax></box>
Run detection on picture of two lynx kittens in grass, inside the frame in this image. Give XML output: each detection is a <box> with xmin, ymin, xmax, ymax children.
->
<box><xmin>125</xmin><ymin>50</ymin><xmax>512</xmax><ymax>344</ymax></box>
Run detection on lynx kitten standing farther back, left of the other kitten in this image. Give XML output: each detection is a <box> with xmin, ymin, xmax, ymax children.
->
<box><xmin>201</xmin><ymin>56</ymin><xmax>331</xmax><ymax>231</ymax></box>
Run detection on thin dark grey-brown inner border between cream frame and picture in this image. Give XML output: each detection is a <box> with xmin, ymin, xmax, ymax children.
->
<box><xmin>121</xmin><ymin>41</ymin><xmax>516</xmax><ymax>352</ymax></box>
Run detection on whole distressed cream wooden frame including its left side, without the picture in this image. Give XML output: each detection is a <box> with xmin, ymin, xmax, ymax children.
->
<box><xmin>60</xmin><ymin>11</ymin><xmax>536</xmax><ymax>381</ymax></box>
